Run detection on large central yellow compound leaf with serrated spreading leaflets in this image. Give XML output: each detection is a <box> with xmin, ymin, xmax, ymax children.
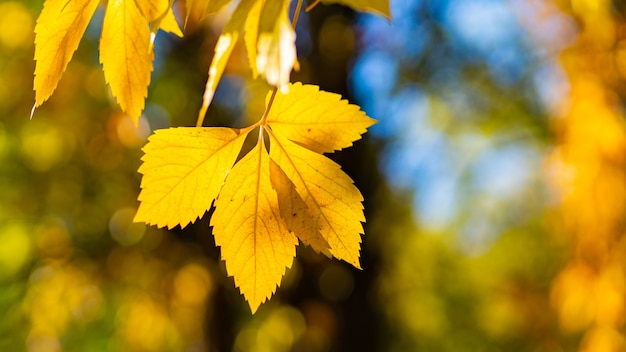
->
<box><xmin>135</xmin><ymin>83</ymin><xmax>374</xmax><ymax>312</ymax></box>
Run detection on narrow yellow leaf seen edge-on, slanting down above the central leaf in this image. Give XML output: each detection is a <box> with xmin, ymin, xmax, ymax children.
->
<box><xmin>198</xmin><ymin>0</ymin><xmax>258</xmax><ymax>127</ymax></box>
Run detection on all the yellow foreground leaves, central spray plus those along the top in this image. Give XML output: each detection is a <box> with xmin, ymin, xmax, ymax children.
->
<box><xmin>33</xmin><ymin>0</ymin><xmax>389</xmax><ymax>312</ymax></box>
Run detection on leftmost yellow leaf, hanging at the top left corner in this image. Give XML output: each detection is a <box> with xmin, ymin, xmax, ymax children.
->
<box><xmin>33</xmin><ymin>0</ymin><xmax>99</xmax><ymax>107</ymax></box>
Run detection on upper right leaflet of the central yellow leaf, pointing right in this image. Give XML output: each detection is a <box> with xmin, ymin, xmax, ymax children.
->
<box><xmin>267</xmin><ymin>83</ymin><xmax>376</xmax><ymax>153</ymax></box>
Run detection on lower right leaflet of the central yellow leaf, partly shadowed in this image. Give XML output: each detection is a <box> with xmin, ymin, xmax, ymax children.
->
<box><xmin>269</xmin><ymin>131</ymin><xmax>365</xmax><ymax>268</ymax></box>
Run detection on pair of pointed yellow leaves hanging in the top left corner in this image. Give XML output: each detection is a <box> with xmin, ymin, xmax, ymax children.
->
<box><xmin>33</xmin><ymin>0</ymin><xmax>182</xmax><ymax>123</ymax></box>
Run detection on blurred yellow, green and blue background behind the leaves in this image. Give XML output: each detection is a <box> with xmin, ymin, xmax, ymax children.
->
<box><xmin>0</xmin><ymin>0</ymin><xmax>626</xmax><ymax>352</ymax></box>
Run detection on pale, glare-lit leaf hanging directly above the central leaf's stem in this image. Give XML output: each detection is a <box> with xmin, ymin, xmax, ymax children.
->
<box><xmin>256</xmin><ymin>0</ymin><xmax>296</xmax><ymax>92</ymax></box>
